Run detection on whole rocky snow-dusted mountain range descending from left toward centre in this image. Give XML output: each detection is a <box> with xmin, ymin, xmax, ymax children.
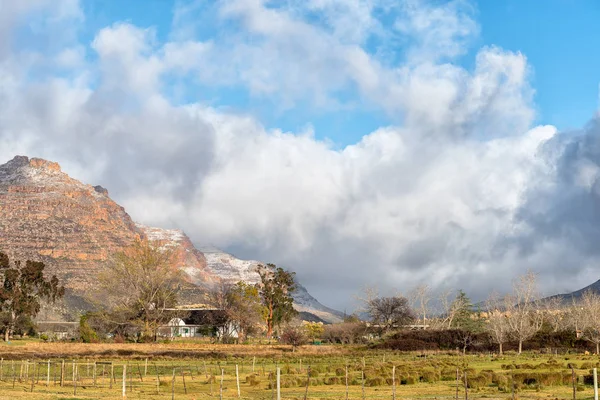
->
<box><xmin>0</xmin><ymin>156</ymin><xmax>341</xmax><ymax>322</ymax></box>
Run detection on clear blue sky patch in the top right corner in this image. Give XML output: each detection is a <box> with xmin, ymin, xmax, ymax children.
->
<box><xmin>478</xmin><ymin>0</ymin><xmax>600</xmax><ymax>130</ymax></box>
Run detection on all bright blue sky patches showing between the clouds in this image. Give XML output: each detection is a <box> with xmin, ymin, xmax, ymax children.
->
<box><xmin>75</xmin><ymin>0</ymin><xmax>600</xmax><ymax>146</ymax></box>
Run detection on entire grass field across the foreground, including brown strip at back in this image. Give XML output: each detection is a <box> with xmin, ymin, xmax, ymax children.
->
<box><xmin>0</xmin><ymin>342</ymin><xmax>600</xmax><ymax>399</ymax></box>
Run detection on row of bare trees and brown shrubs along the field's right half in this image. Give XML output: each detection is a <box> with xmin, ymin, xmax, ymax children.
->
<box><xmin>363</xmin><ymin>273</ymin><xmax>600</xmax><ymax>354</ymax></box>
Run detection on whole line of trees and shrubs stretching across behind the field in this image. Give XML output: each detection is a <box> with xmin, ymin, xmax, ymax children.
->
<box><xmin>0</xmin><ymin>240</ymin><xmax>600</xmax><ymax>354</ymax></box>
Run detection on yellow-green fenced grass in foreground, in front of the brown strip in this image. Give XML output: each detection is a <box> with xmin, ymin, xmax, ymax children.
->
<box><xmin>0</xmin><ymin>344</ymin><xmax>600</xmax><ymax>400</ymax></box>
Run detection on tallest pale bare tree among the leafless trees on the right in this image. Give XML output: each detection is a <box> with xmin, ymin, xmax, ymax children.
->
<box><xmin>504</xmin><ymin>272</ymin><xmax>543</xmax><ymax>354</ymax></box>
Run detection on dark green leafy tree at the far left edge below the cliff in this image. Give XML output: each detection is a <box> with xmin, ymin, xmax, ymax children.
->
<box><xmin>0</xmin><ymin>253</ymin><xmax>65</xmax><ymax>341</ymax></box>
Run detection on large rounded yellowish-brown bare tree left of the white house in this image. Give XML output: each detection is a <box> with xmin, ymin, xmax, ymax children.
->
<box><xmin>97</xmin><ymin>240</ymin><xmax>183</xmax><ymax>340</ymax></box>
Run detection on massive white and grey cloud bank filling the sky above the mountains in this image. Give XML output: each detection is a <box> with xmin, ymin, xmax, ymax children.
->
<box><xmin>0</xmin><ymin>0</ymin><xmax>600</xmax><ymax>308</ymax></box>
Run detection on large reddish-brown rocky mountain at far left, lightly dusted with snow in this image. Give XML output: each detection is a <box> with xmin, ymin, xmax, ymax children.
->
<box><xmin>0</xmin><ymin>157</ymin><xmax>142</xmax><ymax>292</ymax></box>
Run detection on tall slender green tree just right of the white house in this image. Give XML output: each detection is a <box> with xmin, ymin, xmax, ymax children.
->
<box><xmin>257</xmin><ymin>264</ymin><xmax>297</xmax><ymax>338</ymax></box>
